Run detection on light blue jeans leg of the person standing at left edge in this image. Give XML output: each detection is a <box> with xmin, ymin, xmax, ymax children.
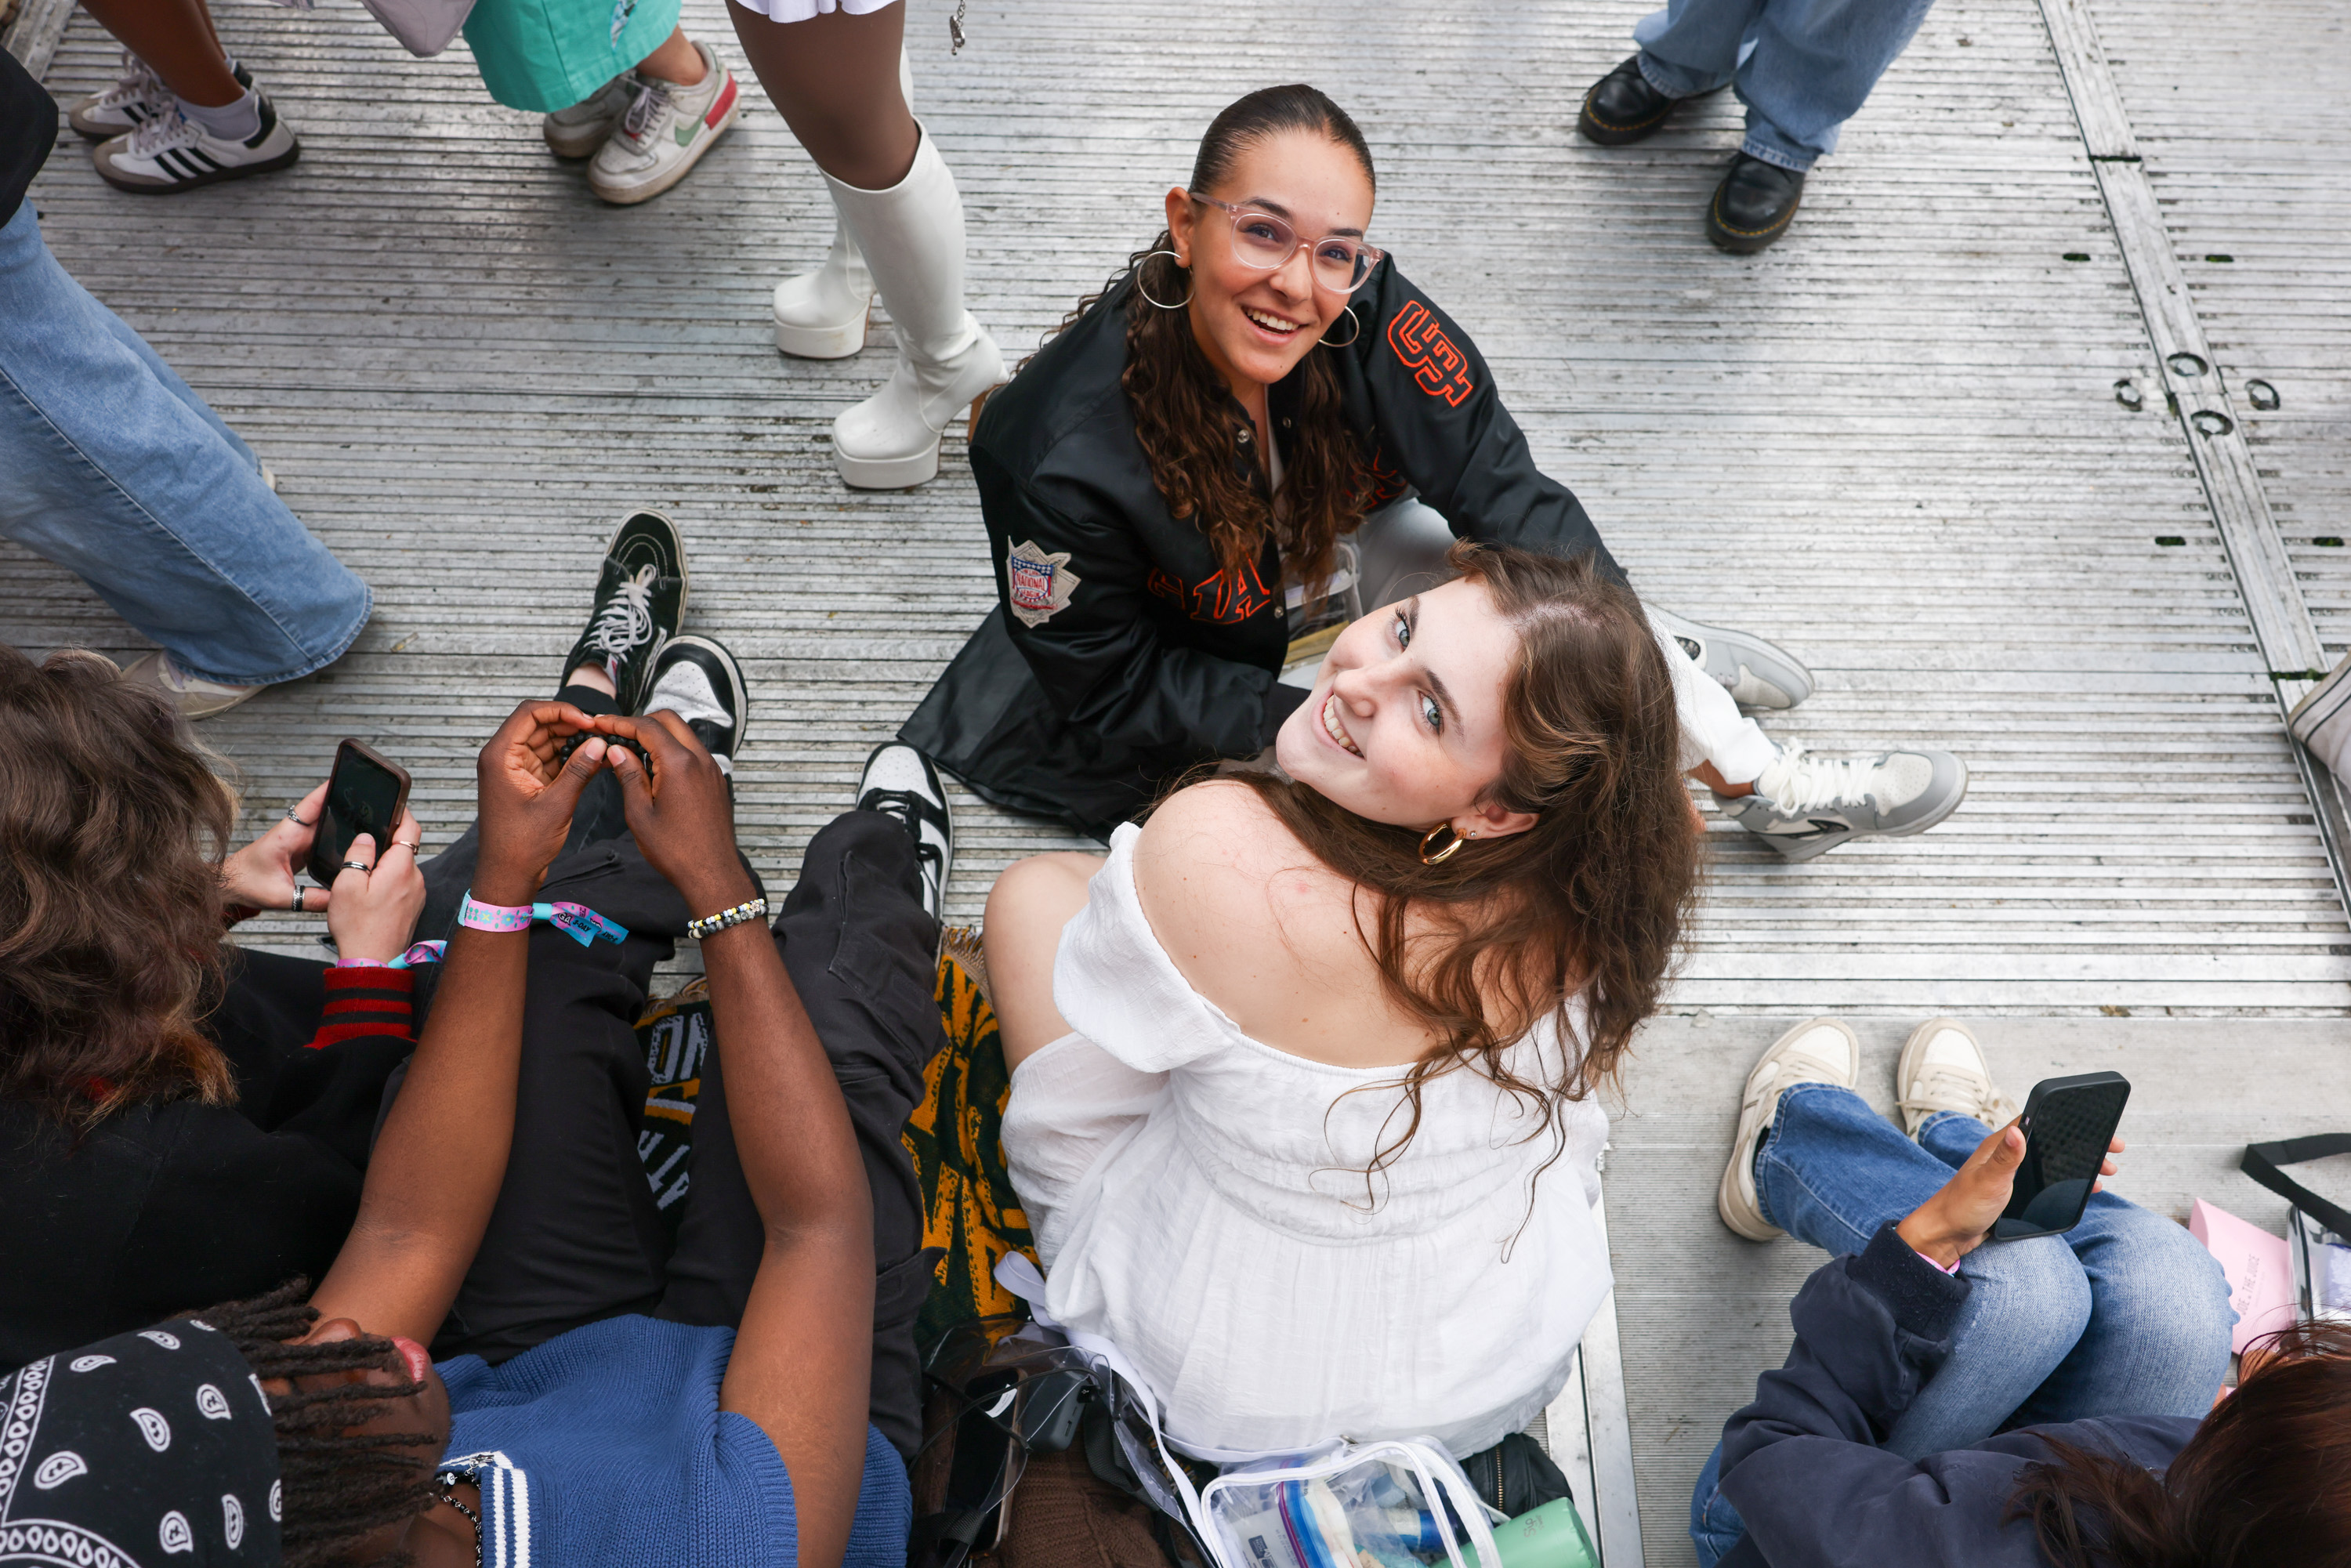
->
<box><xmin>0</xmin><ymin>197</ymin><xmax>374</xmax><ymax>686</ymax></box>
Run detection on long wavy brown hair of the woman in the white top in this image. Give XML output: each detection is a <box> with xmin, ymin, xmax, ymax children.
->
<box><xmin>1204</xmin><ymin>543</ymin><xmax>1700</xmax><ymax>1175</ymax></box>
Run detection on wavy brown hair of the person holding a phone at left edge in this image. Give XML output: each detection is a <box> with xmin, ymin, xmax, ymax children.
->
<box><xmin>0</xmin><ymin>646</ymin><xmax>237</xmax><ymax>1121</ymax></box>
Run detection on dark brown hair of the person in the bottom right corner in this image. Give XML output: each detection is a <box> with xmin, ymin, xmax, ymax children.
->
<box><xmin>2008</xmin><ymin>1324</ymin><xmax>2351</xmax><ymax>1568</ymax></box>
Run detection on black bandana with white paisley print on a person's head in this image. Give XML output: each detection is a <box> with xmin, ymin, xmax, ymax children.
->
<box><xmin>0</xmin><ymin>1319</ymin><xmax>280</xmax><ymax>1568</ymax></box>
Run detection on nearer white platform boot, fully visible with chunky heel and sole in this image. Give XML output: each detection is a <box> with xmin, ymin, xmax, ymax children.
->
<box><xmin>825</xmin><ymin>122</ymin><xmax>1004</xmax><ymax>489</ymax></box>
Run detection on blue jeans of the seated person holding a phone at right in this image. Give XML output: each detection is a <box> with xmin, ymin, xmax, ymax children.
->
<box><xmin>1690</xmin><ymin>1084</ymin><xmax>2236</xmax><ymax>1568</ymax></box>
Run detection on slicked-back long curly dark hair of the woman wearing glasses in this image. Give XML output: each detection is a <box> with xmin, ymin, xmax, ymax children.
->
<box><xmin>1060</xmin><ymin>85</ymin><xmax>1378</xmax><ymax>602</ymax></box>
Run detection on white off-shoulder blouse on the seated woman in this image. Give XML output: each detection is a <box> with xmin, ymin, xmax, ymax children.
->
<box><xmin>1004</xmin><ymin>825</ymin><xmax>1610</xmax><ymax>1458</ymax></box>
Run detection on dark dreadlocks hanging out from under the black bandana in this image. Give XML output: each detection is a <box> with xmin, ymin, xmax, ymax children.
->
<box><xmin>197</xmin><ymin>1279</ymin><xmax>449</xmax><ymax>1568</ymax></box>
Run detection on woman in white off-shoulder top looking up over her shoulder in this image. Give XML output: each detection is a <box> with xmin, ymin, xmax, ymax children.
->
<box><xmin>985</xmin><ymin>545</ymin><xmax>1697</xmax><ymax>1458</ymax></box>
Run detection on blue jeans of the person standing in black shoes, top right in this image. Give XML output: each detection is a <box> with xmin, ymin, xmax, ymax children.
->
<box><xmin>1632</xmin><ymin>0</ymin><xmax>1935</xmax><ymax>172</ymax></box>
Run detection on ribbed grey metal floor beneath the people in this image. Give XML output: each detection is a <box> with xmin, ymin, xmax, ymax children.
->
<box><xmin>13</xmin><ymin>0</ymin><xmax>2351</xmax><ymax>1563</ymax></box>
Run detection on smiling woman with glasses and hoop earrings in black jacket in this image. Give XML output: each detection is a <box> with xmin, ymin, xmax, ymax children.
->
<box><xmin>900</xmin><ymin>85</ymin><xmax>1881</xmax><ymax>849</ymax></box>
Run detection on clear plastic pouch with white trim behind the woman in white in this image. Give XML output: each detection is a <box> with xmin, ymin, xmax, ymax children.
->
<box><xmin>1194</xmin><ymin>1436</ymin><xmax>1500</xmax><ymax>1568</ymax></box>
